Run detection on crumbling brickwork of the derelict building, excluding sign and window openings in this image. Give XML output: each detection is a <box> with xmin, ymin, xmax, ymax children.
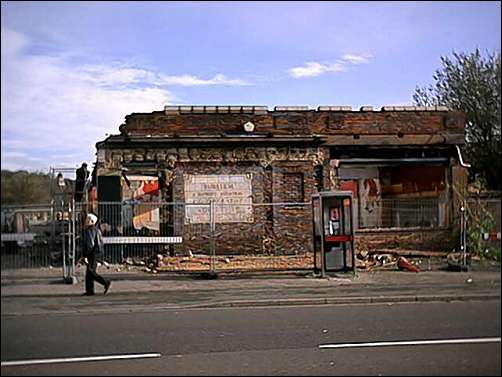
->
<box><xmin>97</xmin><ymin>106</ymin><xmax>464</xmax><ymax>254</ymax></box>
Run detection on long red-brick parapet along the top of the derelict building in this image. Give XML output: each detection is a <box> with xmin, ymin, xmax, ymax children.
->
<box><xmin>121</xmin><ymin>111</ymin><xmax>464</xmax><ymax>136</ymax></box>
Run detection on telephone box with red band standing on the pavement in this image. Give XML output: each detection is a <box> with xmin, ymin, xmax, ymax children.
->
<box><xmin>312</xmin><ymin>191</ymin><xmax>355</xmax><ymax>276</ymax></box>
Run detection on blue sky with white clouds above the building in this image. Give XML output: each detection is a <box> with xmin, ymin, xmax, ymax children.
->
<box><xmin>1</xmin><ymin>1</ymin><xmax>501</xmax><ymax>170</ymax></box>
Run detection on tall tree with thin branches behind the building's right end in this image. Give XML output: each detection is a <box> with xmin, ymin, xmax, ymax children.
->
<box><xmin>413</xmin><ymin>49</ymin><xmax>501</xmax><ymax>190</ymax></box>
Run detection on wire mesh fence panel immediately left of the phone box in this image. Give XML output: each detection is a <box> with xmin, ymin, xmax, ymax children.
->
<box><xmin>214</xmin><ymin>203</ymin><xmax>314</xmax><ymax>271</ymax></box>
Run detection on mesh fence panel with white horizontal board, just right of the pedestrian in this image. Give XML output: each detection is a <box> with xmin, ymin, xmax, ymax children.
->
<box><xmin>97</xmin><ymin>201</ymin><xmax>211</xmax><ymax>271</ymax></box>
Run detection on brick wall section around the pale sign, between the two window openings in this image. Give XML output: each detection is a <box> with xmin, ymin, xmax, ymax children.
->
<box><xmin>173</xmin><ymin>161</ymin><xmax>314</xmax><ymax>255</ymax></box>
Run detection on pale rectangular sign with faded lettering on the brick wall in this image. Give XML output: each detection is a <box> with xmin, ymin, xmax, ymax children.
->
<box><xmin>184</xmin><ymin>174</ymin><xmax>254</xmax><ymax>224</ymax></box>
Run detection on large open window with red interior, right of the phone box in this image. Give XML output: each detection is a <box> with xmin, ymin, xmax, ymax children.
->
<box><xmin>339</xmin><ymin>165</ymin><xmax>447</xmax><ymax>229</ymax></box>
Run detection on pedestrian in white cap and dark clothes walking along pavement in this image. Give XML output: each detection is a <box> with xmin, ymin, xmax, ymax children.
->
<box><xmin>83</xmin><ymin>213</ymin><xmax>111</xmax><ymax>296</ymax></box>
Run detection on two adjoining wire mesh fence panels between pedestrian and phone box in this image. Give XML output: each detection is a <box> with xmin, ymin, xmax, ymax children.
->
<box><xmin>93</xmin><ymin>202</ymin><xmax>313</xmax><ymax>272</ymax></box>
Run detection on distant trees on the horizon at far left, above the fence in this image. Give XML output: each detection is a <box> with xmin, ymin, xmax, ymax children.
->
<box><xmin>1</xmin><ymin>170</ymin><xmax>50</xmax><ymax>204</ymax></box>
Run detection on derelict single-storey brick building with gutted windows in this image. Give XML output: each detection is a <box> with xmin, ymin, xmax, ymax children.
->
<box><xmin>95</xmin><ymin>106</ymin><xmax>467</xmax><ymax>254</ymax></box>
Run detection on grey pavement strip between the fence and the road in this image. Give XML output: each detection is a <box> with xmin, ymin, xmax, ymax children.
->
<box><xmin>1</xmin><ymin>267</ymin><xmax>501</xmax><ymax>315</ymax></box>
